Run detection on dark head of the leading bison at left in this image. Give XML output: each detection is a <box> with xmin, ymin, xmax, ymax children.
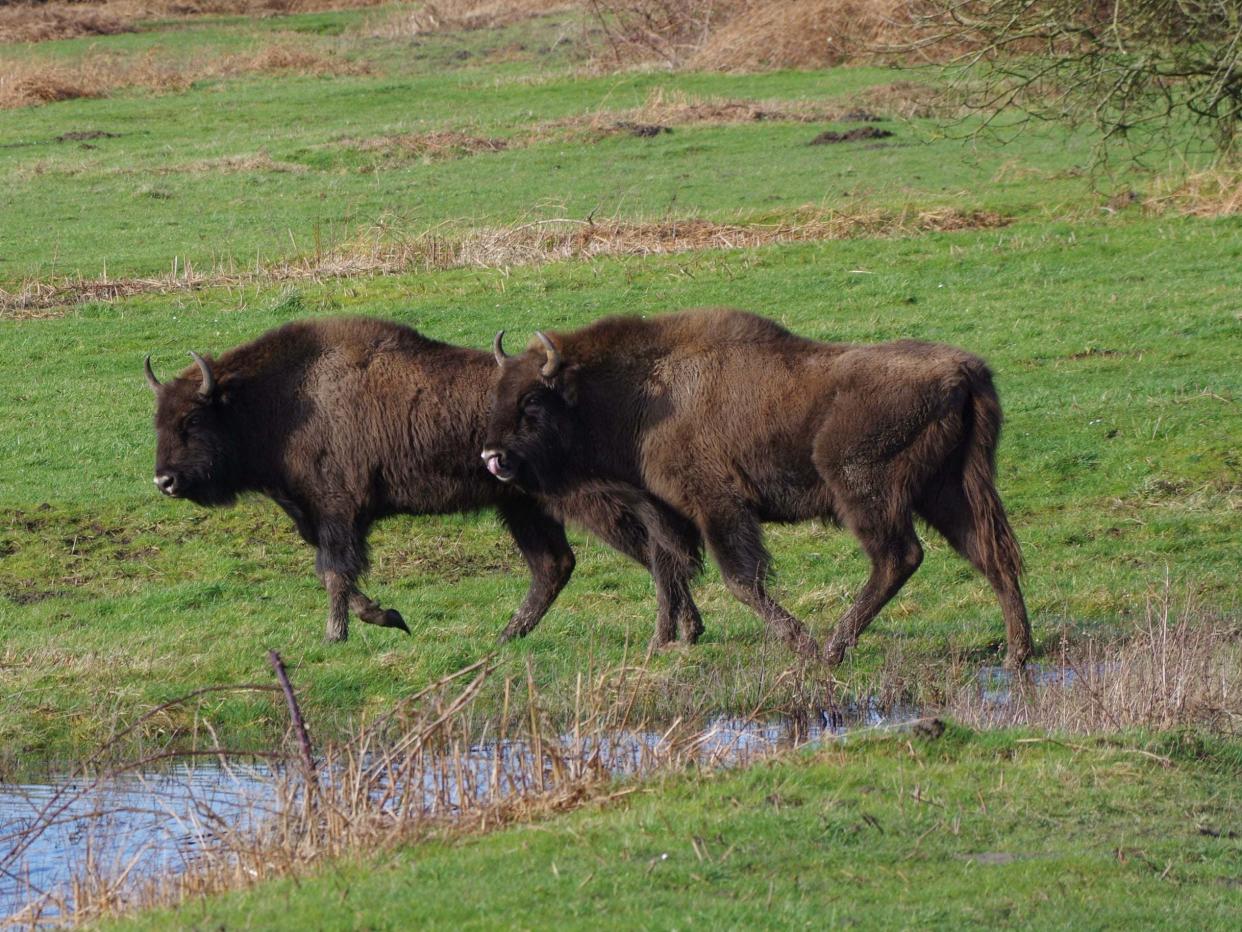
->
<box><xmin>144</xmin><ymin>353</ymin><xmax>237</xmax><ymax>506</ymax></box>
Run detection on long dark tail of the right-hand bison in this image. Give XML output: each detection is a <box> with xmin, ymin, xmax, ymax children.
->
<box><xmin>963</xmin><ymin>360</ymin><xmax>1022</xmax><ymax>578</ymax></box>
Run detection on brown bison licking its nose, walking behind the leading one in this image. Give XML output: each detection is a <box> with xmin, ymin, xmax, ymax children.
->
<box><xmin>483</xmin><ymin>309</ymin><xmax>1031</xmax><ymax>667</ymax></box>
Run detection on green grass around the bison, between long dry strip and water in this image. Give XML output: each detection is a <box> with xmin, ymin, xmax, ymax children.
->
<box><xmin>0</xmin><ymin>214</ymin><xmax>1242</xmax><ymax>758</ymax></box>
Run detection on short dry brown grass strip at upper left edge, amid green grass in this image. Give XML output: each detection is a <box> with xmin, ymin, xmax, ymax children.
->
<box><xmin>0</xmin><ymin>43</ymin><xmax>370</xmax><ymax>109</ymax></box>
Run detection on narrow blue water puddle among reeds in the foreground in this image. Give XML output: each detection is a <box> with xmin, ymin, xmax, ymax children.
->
<box><xmin>0</xmin><ymin>706</ymin><xmax>919</xmax><ymax>925</ymax></box>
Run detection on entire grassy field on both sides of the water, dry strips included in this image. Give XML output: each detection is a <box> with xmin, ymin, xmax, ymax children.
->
<box><xmin>0</xmin><ymin>7</ymin><xmax>1242</xmax><ymax>928</ymax></box>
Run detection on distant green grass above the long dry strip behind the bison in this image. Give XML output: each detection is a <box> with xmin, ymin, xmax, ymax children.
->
<box><xmin>0</xmin><ymin>12</ymin><xmax>1124</xmax><ymax>285</ymax></box>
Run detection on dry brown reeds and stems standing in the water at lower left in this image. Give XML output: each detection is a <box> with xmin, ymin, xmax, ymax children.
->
<box><xmin>0</xmin><ymin>660</ymin><xmax>834</xmax><ymax>927</ymax></box>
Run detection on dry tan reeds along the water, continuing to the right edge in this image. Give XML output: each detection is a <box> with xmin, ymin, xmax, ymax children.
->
<box><xmin>0</xmin><ymin>584</ymin><xmax>1242</xmax><ymax>926</ymax></box>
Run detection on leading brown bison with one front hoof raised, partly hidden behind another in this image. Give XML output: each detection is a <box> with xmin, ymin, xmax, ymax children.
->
<box><xmin>144</xmin><ymin>318</ymin><xmax>702</xmax><ymax>641</ymax></box>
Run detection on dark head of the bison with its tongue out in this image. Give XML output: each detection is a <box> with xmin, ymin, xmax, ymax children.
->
<box><xmin>483</xmin><ymin>331</ymin><xmax>576</xmax><ymax>492</ymax></box>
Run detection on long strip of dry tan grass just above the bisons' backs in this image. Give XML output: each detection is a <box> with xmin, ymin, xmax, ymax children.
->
<box><xmin>0</xmin><ymin>208</ymin><xmax>1010</xmax><ymax>319</ymax></box>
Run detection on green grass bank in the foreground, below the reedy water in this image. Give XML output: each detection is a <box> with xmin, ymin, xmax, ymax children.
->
<box><xmin>107</xmin><ymin>729</ymin><xmax>1242</xmax><ymax>930</ymax></box>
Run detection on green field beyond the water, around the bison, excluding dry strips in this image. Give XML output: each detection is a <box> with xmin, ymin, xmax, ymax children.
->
<box><xmin>0</xmin><ymin>5</ymin><xmax>1242</xmax><ymax>769</ymax></box>
